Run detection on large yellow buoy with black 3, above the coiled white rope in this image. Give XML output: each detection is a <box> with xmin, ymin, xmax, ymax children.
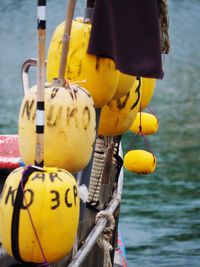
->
<box><xmin>98</xmin><ymin>80</ymin><xmax>141</xmax><ymax>136</ymax></box>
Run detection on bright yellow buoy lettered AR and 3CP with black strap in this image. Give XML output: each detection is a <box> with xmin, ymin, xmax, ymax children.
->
<box><xmin>0</xmin><ymin>167</ymin><xmax>80</xmax><ymax>263</ymax></box>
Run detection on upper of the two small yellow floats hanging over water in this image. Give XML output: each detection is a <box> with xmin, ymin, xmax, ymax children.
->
<box><xmin>130</xmin><ymin>112</ymin><xmax>159</xmax><ymax>135</ymax></box>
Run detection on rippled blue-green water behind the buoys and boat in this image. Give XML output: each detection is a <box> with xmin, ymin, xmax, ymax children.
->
<box><xmin>0</xmin><ymin>0</ymin><xmax>200</xmax><ymax>267</ymax></box>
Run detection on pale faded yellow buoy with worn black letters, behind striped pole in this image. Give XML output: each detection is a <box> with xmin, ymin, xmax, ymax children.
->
<box><xmin>18</xmin><ymin>84</ymin><xmax>96</xmax><ymax>173</ymax></box>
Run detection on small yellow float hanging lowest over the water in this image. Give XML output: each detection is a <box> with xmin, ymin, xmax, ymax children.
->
<box><xmin>124</xmin><ymin>150</ymin><xmax>156</xmax><ymax>174</ymax></box>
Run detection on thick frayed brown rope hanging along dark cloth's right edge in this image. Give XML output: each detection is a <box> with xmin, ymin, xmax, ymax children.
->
<box><xmin>157</xmin><ymin>0</ymin><xmax>170</xmax><ymax>54</ymax></box>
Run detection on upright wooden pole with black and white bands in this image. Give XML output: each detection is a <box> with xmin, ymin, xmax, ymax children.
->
<box><xmin>35</xmin><ymin>0</ymin><xmax>46</xmax><ymax>167</ymax></box>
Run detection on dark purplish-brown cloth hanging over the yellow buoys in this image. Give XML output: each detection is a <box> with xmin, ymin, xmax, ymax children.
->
<box><xmin>88</xmin><ymin>0</ymin><xmax>163</xmax><ymax>79</ymax></box>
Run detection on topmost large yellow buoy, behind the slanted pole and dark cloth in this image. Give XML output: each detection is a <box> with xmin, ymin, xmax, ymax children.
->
<box><xmin>47</xmin><ymin>18</ymin><xmax>119</xmax><ymax>108</ymax></box>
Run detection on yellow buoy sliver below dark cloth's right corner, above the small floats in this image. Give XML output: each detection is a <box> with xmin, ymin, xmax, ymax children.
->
<box><xmin>141</xmin><ymin>78</ymin><xmax>156</xmax><ymax>110</ymax></box>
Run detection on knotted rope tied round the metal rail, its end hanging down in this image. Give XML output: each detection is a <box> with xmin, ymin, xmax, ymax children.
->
<box><xmin>95</xmin><ymin>210</ymin><xmax>115</xmax><ymax>267</ymax></box>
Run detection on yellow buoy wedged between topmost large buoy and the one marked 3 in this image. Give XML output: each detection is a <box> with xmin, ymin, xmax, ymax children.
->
<box><xmin>113</xmin><ymin>72</ymin><xmax>136</xmax><ymax>99</ymax></box>
